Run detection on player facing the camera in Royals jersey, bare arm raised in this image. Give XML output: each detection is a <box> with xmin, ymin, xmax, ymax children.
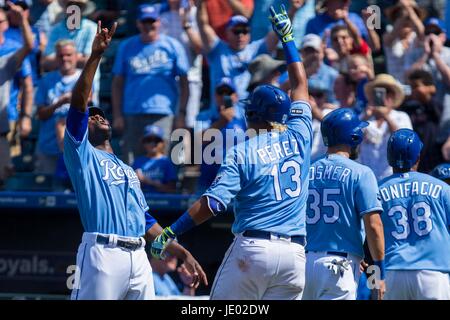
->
<box><xmin>64</xmin><ymin>22</ymin><xmax>206</xmax><ymax>300</ymax></box>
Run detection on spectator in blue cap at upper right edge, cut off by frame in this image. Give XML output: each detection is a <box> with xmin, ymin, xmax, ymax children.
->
<box><xmin>410</xmin><ymin>18</ymin><xmax>450</xmax><ymax>140</ymax></box>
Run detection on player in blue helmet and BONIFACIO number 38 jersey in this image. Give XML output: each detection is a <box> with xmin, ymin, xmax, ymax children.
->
<box><xmin>379</xmin><ymin>129</ymin><xmax>450</xmax><ymax>300</ymax></box>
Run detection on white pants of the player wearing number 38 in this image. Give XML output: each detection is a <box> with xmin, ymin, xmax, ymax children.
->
<box><xmin>384</xmin><ymin>270</ymin><xmax>450</xmax><ymax>300</ymax></box>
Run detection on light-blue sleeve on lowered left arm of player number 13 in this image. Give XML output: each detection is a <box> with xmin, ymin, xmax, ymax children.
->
<box><xmin>203</xmin><ymin>145</ymin><xmax>244</xmax><ymax>210</ymax></box>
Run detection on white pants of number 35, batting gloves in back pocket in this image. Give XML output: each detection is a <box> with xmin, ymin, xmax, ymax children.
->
<box><xmin>303</xmin><ymin>251</ymin><xmax>361</xmax><ymax>300</ymax></box>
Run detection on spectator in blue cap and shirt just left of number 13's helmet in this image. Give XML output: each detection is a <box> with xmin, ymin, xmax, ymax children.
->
<box><xmin>197</xmin><ymin>78</ymin><xmax>247</xmax><ymax>192</ymax></box>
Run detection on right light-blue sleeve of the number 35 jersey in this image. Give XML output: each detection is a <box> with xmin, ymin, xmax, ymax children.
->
<box><xmin>355</xmin><ymin>169</ymin><xmax>383</xmax><ymax>216</ymax></box>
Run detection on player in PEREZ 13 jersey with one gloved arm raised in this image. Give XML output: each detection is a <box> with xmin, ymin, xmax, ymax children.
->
<box><xmin>152</xmin><ymin>7</ymin><xmax>312</xmax><ymax>300</ymax></box>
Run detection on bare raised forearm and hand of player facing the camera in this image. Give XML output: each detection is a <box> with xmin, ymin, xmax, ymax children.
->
<box><xmin>70</xmin><ymin>21</ymin><xmax>117</xmax><ymax>113</ymax></box>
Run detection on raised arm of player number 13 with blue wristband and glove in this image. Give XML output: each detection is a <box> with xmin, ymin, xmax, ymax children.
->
<box><xmin>270</xmin><ymin>6</ymin><xmax>309</xmax><ymax>101</ymax></box>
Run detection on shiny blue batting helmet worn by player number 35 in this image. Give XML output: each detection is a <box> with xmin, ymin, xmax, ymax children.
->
<box><xmin>320</xmin><ymin>108</ymin><xmax>369</xmax><ymax>148</ymax></box>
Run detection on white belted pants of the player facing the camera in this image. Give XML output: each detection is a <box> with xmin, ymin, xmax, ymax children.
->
<box><xmin>71</xmin><ymin>232</ymin><xmax>155</xmax><ymax>300</ymax></box>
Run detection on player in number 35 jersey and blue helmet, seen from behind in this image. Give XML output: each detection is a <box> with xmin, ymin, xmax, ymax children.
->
<box><xmin>303</xmin><ymin>108</ymin><xmax>385</xmax><ymax>300</ymax></box>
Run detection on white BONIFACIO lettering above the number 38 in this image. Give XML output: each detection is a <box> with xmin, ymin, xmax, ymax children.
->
<box><xmin>380</xmin><ymin>181</ymin><xmax>442</xmax><ymax>201</ymax></box>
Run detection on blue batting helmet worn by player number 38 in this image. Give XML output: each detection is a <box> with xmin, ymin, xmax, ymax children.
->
<box><xmin>387</xmin><ymin>129</ymin><xmax>423</xmax><ymax>170</ymax></box>
